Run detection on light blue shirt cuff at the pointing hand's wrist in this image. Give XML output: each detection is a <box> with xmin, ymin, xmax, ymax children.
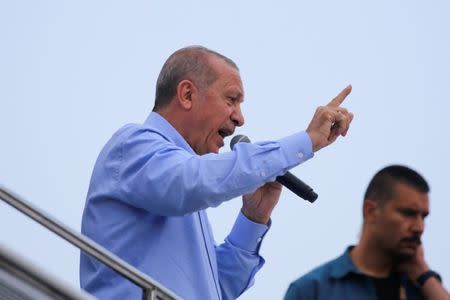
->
<box><xmin>278</xmin><ymin>131</ymin><xmax>314</xmax><ymax>165</ymax></box>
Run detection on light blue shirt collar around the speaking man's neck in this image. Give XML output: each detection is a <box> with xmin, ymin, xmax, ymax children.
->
<box><xmin>144</xmin><ymin>112</ymin><xmax>195</xmax><ymax>154</ymax></box>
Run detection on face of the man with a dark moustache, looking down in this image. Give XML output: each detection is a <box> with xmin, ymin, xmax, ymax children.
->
<box><xmin>374</xmin><ymin>183</ymin><xmax>429</xmax><ymax>260</ymax></box>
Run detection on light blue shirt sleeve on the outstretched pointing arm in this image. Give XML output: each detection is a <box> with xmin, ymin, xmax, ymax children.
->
<box><xmin>103</xmin><ymin>127</ymin><xmax>313</xmax><ymax>216</ymax></box>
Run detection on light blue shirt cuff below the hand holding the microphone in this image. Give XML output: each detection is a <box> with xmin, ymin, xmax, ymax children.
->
<box><xmin>228</xmin><ymin>212</ymin><xmax>271</xmax><ymax>253</ymax></box>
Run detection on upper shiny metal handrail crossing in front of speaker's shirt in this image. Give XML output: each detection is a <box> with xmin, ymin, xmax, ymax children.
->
<box><xmin>0</xmin><ymin>187</ymin><xmax>178</xmax><ymax>300</ymax></box>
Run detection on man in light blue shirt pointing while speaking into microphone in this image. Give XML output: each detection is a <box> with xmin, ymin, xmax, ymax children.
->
<box><xmin>80</xmin><ymin>46</ymin><xmax>353</xmax><ymax>300</ymax></box>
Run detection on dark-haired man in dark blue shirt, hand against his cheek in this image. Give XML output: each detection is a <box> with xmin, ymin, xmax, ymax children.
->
<box><xmin>284</xmin><ymin>165</ymin><xmax>450</xmax><ymax>300</ymax></box>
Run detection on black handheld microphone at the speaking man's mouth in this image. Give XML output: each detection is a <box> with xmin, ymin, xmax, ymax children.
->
<box><xmin>230</xmin><ymin>134</ymin><xmax>318</xmax><ymax>203</ymax></box>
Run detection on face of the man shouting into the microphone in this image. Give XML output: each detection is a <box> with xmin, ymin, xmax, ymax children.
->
<box><xmin>189</xmin><ymin>57</ymin><xmax>244</xmax><ymax>155</ymax></box>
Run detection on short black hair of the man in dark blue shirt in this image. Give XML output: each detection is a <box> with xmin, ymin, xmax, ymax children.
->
<box><xmin>364</xmin><ymin>165</ymin><xmax>430</xmax><ymax>204</ymax></box>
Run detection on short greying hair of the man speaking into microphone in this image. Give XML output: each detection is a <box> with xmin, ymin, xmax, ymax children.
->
<box><xmin>153</xmin><ymin>46</ymin><xmax>239</xmax><ymax>111</ymax></box>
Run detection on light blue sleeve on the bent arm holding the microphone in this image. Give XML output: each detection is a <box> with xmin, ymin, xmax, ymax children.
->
<box><xmin>216</xmin><ymin>213</ymin><xmax>270</xmax><ymax>300</ymax></box>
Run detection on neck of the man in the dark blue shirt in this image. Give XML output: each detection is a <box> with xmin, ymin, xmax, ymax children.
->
<box><xmin>350</xmin><ymin>234</ymin><xmax>393</xmax><ymax>278</ymax></box>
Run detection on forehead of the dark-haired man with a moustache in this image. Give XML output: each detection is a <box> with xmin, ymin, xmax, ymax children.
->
<box><xmin>387</xmin><ymin>183</ymin><xmax>429</xmax><ymax>212</ymax></box>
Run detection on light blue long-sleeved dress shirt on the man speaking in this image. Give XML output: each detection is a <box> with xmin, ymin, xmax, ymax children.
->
<box><xmin>80</xmin><ymin>112</ymin><xmax>313</xmax><ymax>300</ymax></box>
